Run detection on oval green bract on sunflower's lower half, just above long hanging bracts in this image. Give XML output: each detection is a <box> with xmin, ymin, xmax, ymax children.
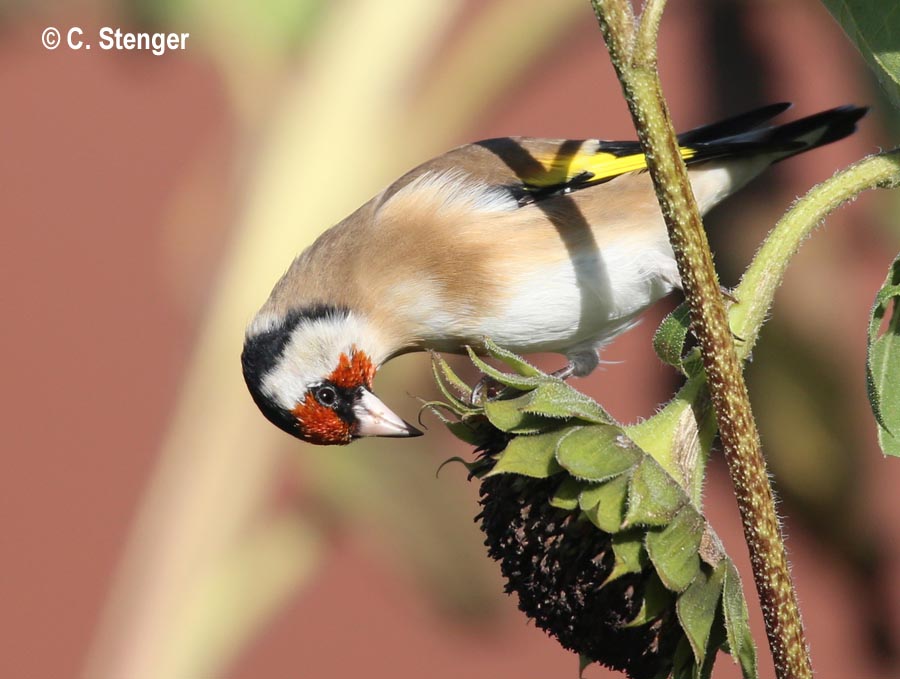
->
<box><xmin>647</xmin><ymin>506</ymin><xmax>705</xmax><ymax>592</ymax></box>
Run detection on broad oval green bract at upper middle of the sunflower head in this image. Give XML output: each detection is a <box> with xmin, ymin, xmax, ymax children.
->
<box><xmin>556</xmin><ymin>425</ymin><xmax>641</xmax><ymax>481</ymax></box>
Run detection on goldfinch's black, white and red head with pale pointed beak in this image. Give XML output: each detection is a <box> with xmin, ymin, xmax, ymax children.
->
<box><xmin>241</xmin><ymin>306</ymin><xmax>422</xmax><ymax>445</ymax></box>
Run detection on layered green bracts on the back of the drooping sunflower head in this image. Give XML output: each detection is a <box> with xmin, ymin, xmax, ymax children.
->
<box><xmin>431</xmin><ymin>306</ymin><xmax>760</xmax><ymax>679</ymax></box>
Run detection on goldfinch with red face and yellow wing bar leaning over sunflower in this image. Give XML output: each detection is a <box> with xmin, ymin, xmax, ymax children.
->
<box><xmin>241</xmin><ymin>103</ymin><xmax>867</xmax><ymax>445</ymax></box>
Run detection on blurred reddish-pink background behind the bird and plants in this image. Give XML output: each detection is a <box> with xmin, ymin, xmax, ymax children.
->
<box><xmin>0</xmin><ymin>0</ymin><xmax>900</xmax><ymax>679</ymax></box>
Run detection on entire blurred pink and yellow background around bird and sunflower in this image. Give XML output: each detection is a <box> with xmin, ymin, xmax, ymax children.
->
<box><xmin>0</xmin><ymin>0</ymin><xmax>900</xmax><ymax>679</ymax></box>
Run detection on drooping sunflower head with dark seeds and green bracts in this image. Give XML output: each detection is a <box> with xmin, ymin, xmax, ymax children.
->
<box><xmin>435</xmin><ymin>346</ymin><xmax>756</xmax><ymax>679</ymax></box>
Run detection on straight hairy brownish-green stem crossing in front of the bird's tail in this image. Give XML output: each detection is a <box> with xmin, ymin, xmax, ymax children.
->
<box><xmin>591</xmin><ymin>0</ymin><xmax>812</xmax><ymax>679</ymax></box>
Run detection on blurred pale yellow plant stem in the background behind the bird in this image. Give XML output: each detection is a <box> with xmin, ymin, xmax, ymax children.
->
<box><xmin>85</xmin><ymin>0</ymin><xmax>585</xmax><ymax>679</ymax></box>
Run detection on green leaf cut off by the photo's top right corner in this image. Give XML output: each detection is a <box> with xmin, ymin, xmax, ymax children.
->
<box><xmin>822</xmin><ymin>0</ymin><xmax>900</xmax><ymax>107</ymax></box>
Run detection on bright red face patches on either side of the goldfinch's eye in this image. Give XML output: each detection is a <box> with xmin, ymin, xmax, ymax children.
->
<box><xmin>291</xmin><ymin>347</ymin><xmax>375</xmax><ymax>445</ymax></box>
